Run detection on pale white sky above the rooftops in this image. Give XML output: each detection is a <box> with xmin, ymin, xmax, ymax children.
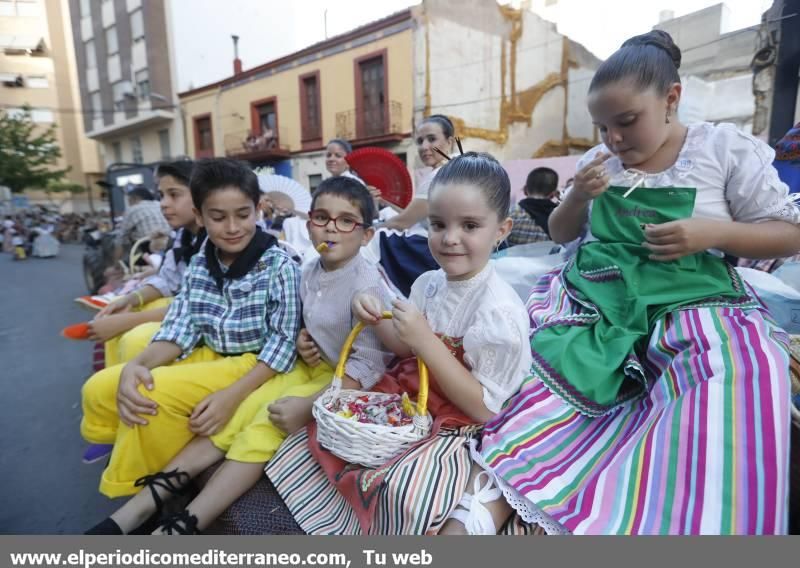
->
<box><xmin>177</xmin><ymin>0</ymin><xmax>772</xmax><ymax>90</ymax></box>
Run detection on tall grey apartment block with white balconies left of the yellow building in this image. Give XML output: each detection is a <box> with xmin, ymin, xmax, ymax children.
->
<box><xmin>70</xmin><ymin>0</ymin><xmax>183</xmax><ymax>166</ymax></box>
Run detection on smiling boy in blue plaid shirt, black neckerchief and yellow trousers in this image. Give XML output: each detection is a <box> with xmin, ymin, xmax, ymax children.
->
<box><xmin>81</xmin><ymin>159</ymin><xmax>301</xmax><ymax>532</ymax></box>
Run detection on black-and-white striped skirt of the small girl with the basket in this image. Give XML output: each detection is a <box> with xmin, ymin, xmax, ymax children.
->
<box><xmin>266</xmin><ymin>427</ymin><xmax>541</xmax><ymax>535</ymax></box>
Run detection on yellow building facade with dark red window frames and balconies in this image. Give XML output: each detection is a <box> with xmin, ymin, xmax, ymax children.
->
<box><xmin>180</xmin><ymin>10</ymin><xmax>414</xmax><ymax>193</ymax></box>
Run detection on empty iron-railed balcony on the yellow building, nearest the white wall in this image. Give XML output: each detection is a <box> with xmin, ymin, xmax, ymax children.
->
<box><xmin>336</xmin><ymin>101</ymin><xmax>405</xmax><ymax>146</ymax></box>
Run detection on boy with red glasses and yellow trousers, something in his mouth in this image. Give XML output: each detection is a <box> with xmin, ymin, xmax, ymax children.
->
<box><xmin>89</xmin><ymin>176</ymin><xmax>392</xmax><ymax>534</ymax></box>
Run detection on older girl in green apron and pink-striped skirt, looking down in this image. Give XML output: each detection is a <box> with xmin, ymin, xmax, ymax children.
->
<box><xmin>447</xmin><ymin>31</ymin><xmax>800</xmax><ymax>534</ymax></box>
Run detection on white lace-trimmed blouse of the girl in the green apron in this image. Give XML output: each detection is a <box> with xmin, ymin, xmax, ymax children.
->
<box><xmin>577</xmin><ymin>122</ymin><xmax>800</xmax><ymax>241</ymax></box>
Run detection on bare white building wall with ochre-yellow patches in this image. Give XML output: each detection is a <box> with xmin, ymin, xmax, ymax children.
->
<box><xmin>413</xmin><ymin>0</ymin><xmax>600</xmax><ymax>160</ymax></box>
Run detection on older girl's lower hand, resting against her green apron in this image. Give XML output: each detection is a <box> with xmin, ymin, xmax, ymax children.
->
<box><xmin>642</xmin><ymin>218</ymin><xmax>724</xmax><ymax>261</ymax></box>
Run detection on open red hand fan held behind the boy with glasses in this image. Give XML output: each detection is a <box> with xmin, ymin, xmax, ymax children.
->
<box><xmin>345</xmin><ymin>148</ymin><xmax>414</xmax><ymax>207</ymax></box>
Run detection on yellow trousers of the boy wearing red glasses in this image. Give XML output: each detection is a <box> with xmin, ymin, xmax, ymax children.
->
<box><xmin>210</xmin><ymin>360</ymin><xmax>333</xmax><ymax>463</ymax></box>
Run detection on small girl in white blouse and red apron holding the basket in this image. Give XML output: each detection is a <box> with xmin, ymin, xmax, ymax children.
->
<box><xmin>266</xmin><ymin>154</ymin><xmax>531</xmax><ymax>534</ymax></box>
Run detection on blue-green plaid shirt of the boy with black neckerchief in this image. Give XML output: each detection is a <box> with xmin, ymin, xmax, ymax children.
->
<box><xmin>153</xmin><ymin>246</ymin><xmax>302</xmax><ymax>373</ymax></box>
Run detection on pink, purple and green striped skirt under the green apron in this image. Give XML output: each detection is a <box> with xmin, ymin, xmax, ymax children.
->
<box><xmin>473</xmin><ymin>272</ymin><xmax>790</xmax><ymax>534</ymax></box>
